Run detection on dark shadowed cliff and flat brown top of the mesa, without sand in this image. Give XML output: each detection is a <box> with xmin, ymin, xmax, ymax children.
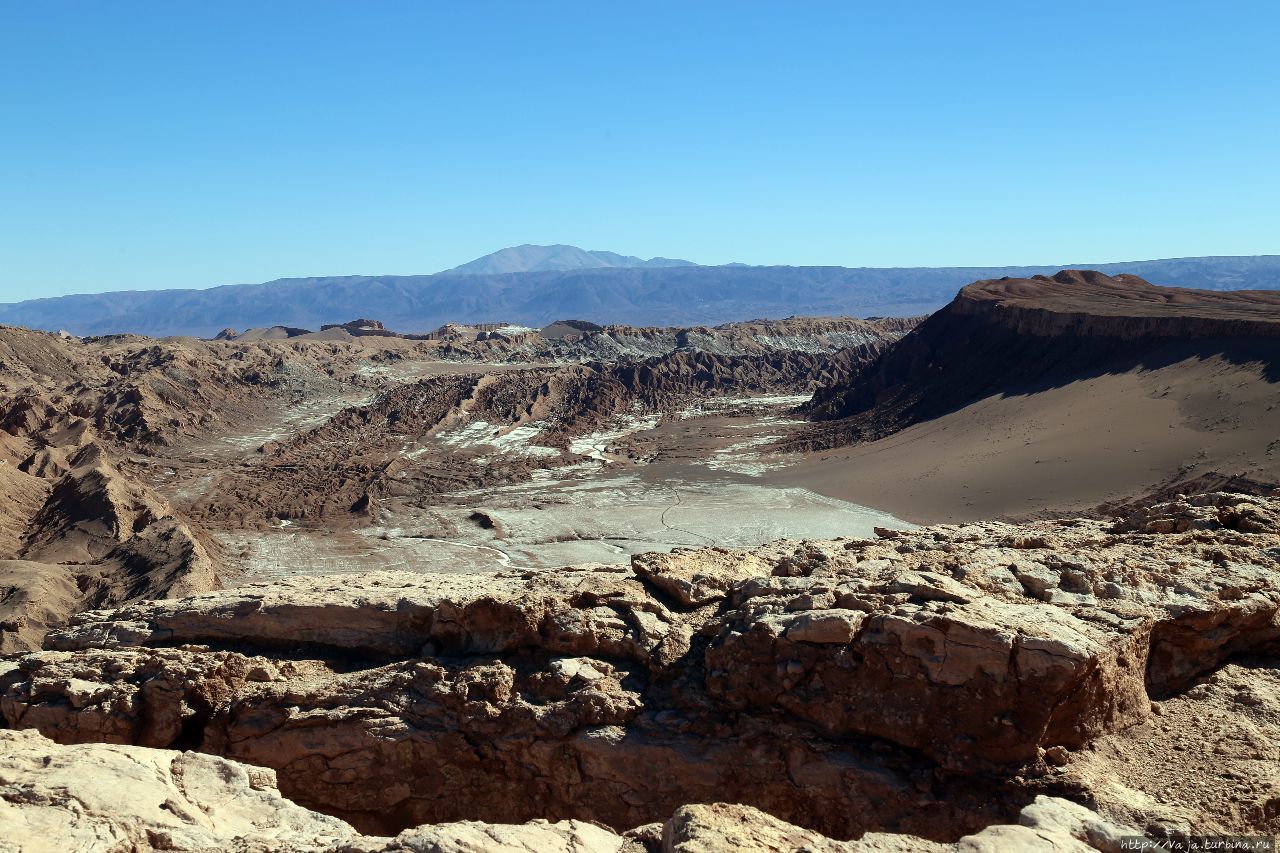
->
<box><xmin>809</xmin><ymin>270</ymin><xmax>1280</xmax><ymax>446</ymax></box>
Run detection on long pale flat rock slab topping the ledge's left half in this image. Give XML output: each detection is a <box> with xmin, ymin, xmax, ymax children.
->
<box><xmin>49</xmin><ymin>566</ymin><xmax>671</xmax><ymax>662</ymax></box>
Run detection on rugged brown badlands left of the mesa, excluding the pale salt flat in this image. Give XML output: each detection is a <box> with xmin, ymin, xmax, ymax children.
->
<box><xmin>0</xmin><ymin>320</ymin><xmax>911</xmax><ymax>648</ymax></box>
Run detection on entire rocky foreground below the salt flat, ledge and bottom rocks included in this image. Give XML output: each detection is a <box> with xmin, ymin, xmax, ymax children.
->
<box><xmin>0</xmin><ymin>493</ymin><xmax>1280</xmax><ymax>850</ymax></box>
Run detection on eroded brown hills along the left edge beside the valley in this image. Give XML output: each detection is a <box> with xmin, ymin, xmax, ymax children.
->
<box><xmin>0</xmin><ymin>322</ymin><xmax>409</xmax><ymax>651</ymax></box>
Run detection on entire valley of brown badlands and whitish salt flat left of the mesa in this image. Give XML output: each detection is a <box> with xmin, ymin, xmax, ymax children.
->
<box><xmin>0</xmin><ymin>312</ymin><xmax>915</xmax><ymax>649</ymax></box>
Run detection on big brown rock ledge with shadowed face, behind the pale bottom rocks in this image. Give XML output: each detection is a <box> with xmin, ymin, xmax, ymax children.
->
<box><xmin>0</xmin><ymin>494</ymin><xmax>1280</xmax><ymax>840</ymax></box>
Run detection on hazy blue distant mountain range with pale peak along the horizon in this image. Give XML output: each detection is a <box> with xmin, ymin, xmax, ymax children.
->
<box><xmin>0</xmin><ymin>246</ymin><xmax>1280</xmax><ymax>337</ymax></box>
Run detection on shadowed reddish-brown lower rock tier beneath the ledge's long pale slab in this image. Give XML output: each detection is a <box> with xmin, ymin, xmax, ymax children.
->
<box><xmin>3</xmin><ymin>640</ymin><xmax>977</xmax><ymax>836</ymax></box>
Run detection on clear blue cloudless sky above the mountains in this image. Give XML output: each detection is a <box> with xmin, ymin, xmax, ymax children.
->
<box><xmin>0</xmin><ymin>0</ymin><xmax>1280</xmax><ymax>301</ymax></box>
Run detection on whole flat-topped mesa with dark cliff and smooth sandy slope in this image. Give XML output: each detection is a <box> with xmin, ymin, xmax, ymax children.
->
<box><xmin>776</xmin><ymin>272</ymin><xmax>1280</xmax><ymax>521</ymax></box>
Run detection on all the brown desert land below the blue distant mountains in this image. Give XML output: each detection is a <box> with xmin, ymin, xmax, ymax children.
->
<box><xmin>0</xmin><ymin>272</ymin><xmax>1280</xmax><ymax>853</ymax></box>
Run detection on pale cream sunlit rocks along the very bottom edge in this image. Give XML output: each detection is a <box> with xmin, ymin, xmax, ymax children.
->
<box><xmin>0</xmin><ymin>731</ymin><xmax>1135</xmax><ymax>853</ymax></box>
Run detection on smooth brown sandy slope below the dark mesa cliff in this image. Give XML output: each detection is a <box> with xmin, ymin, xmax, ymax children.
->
<box><xmin>769</xmin><ymin>356</ymin><xmax>1280</xmax><ymax>523</ymax></box>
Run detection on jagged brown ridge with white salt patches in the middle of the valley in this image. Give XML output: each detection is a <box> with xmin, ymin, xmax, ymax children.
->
<box><xmin>192</xmin><ymin>346</ymin><xmax>879</xmax><ymax>526</ymax></box>
